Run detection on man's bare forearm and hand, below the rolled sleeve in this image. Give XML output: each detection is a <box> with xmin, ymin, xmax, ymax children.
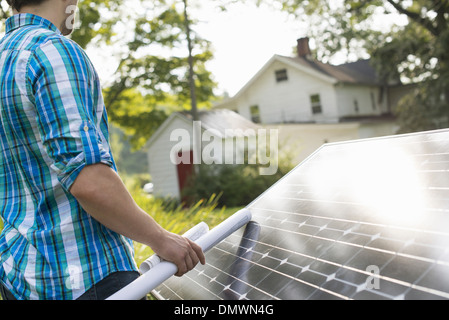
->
<box><xmin>70</xmin><ymin>164</ymin><xmax>205</xmax><ymax>276</ymax></box>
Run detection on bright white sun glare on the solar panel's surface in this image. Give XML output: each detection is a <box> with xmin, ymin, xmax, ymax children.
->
<box><xmin>305</xmin><ymin>143</ymin><xmax>424</xmax><ymax>224</ymax></box>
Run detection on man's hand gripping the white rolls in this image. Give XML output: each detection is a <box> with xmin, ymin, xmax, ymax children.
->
<box><xmin>152</xmin><ymin>232</ymin><xmax>206</xmax><ymax>277</ymax></box>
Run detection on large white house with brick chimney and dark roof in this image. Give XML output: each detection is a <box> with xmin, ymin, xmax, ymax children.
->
<box><xmin>215</xmin><ymin>38</ymin><xmax>404</xmax><ymax>124</ymax></box>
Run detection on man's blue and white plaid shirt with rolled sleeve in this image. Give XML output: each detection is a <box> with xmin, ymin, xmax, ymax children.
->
<box><xmin>0</xmin><ymin>14</ymin><xmax>137</xmax><ymax>299</ymax></box>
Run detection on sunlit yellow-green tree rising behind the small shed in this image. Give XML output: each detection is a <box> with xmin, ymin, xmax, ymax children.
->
<box><xmin>105</xmin><ymin>1</ymin><xmax>216</xmax><ymax>148</ymax></box>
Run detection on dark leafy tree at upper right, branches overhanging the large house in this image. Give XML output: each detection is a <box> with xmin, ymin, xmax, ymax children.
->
<box><xmin>229</xmin><ymin>0</ymin><xmax>449</xmax><ymax>132</ymax></box>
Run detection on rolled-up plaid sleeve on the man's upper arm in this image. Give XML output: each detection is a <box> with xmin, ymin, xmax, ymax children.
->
<box><xmin>28</xmin><ymin>38</ymin><xmax>114</xmax><ymax>191</ymax></box>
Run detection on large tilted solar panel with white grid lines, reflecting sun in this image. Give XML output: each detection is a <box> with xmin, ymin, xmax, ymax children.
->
<box><xmin>154</xmin><ymin>130</ymin><xmax>449</xmax><ymax>300</ymax></box>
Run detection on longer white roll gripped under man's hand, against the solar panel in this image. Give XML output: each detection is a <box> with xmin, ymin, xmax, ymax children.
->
<box><xmin>106</xmin><ymin>208</ymin><xmax>251</xmax><ymax>300</ymax></box>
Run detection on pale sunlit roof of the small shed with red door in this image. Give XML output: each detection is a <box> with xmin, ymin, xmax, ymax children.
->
<box><xmin>145</xmin><ymin>109</ymin><xmax>260</xmax><ymax>149</ymax></box>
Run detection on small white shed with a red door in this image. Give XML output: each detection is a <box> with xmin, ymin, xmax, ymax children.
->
<box><xmin>146</xmin><ymin>110</ymin><xmax>260</xmax><ymax>199</ymax></box>
